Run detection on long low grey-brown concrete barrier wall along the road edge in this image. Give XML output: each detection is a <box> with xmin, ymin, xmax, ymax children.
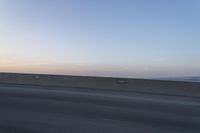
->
<box><xmin>0</xmin><ymin>73</ymin><xmax>200</xmax><ymax>97</ymax></box>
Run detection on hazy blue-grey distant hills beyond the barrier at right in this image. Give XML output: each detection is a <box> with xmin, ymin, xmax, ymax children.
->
<box><xmin>157</xmin><ymin>76</ymin><xmax>200</xmax><ymax>82</ymax></box>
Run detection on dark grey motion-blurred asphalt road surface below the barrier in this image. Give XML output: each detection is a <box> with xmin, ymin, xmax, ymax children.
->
<box><xmin>0</xmin><ymin>84</ymin><xmax>200</xmax><ymax>133</ymax></box>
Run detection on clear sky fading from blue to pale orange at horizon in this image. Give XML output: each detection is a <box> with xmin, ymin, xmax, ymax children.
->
<box><xmin>0</xmin><ymin>0</ymin><xmax>200</xmax><ymax>78</ymax></box>
